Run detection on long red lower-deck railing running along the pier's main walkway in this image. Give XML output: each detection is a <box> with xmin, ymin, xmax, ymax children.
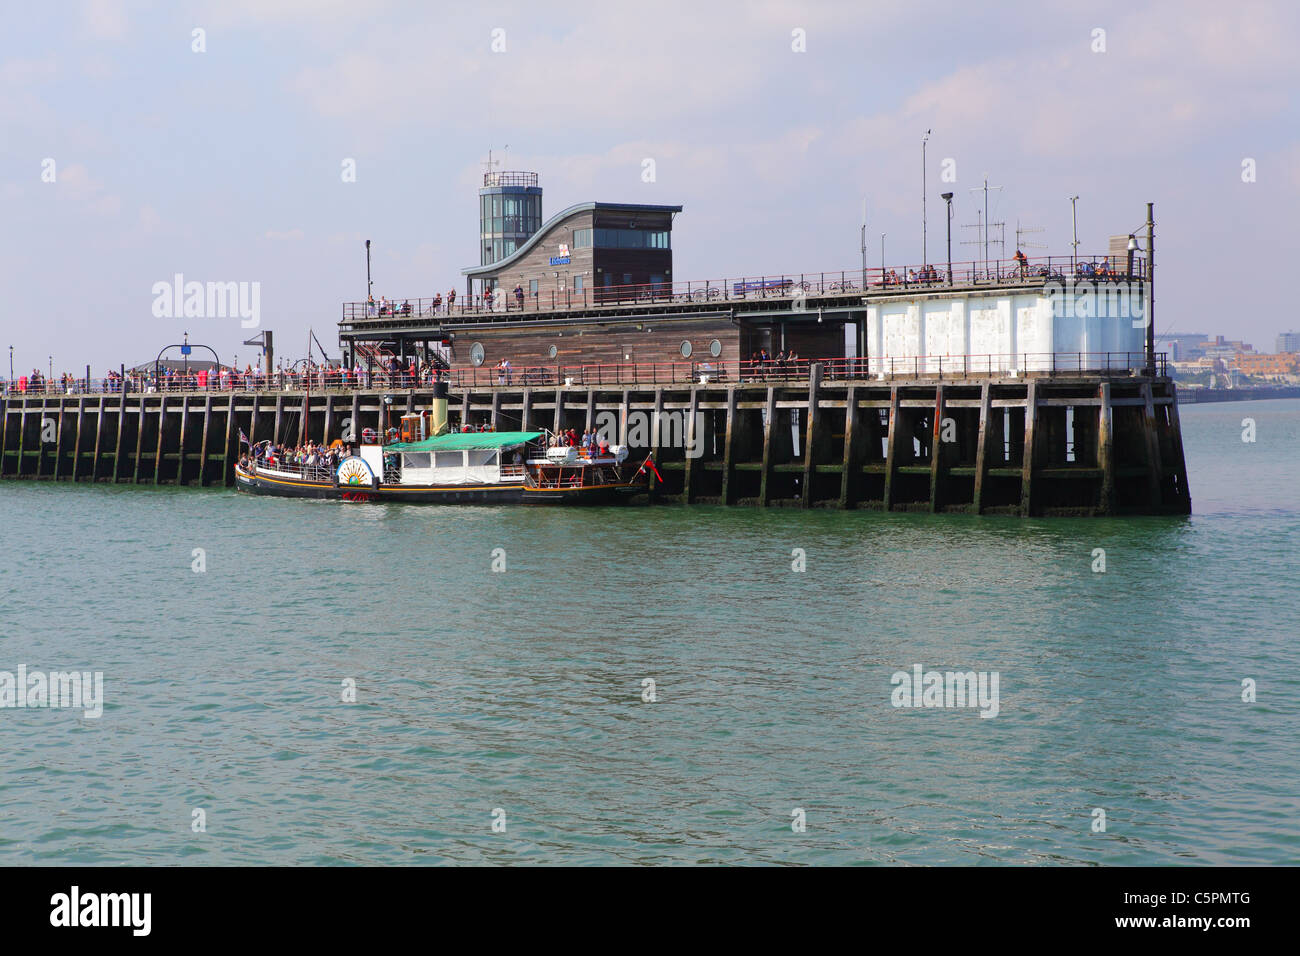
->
<box><xmin>4</xmin><ymin>352</ymin><xmax>1169</xmax><ymax>397</ymax></box>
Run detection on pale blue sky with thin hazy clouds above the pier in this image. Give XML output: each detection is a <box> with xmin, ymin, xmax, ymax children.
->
<box><xmin>0</xmin><ymin>0</ymin><xmax>1300</xmax><ymax>377</ymax></box>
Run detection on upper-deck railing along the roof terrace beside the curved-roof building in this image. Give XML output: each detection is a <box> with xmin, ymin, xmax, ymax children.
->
<box><xmin>343</xmin><ymin>256</ymin><xmax>1145</xmax><ymax>324</ymax></box>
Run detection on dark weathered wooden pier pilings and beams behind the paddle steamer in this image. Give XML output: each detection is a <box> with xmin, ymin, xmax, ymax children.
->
<box><xmin>0</xmin><ymin>364</ymin><xmax>1191</xmax><ymax>515</ymax></box>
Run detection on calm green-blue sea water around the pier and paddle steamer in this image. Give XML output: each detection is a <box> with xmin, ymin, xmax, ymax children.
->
<box><xmin>0</xmin><ymin>401</ymin><xmax>1300</xmax><ymax>865</ymax></box>
